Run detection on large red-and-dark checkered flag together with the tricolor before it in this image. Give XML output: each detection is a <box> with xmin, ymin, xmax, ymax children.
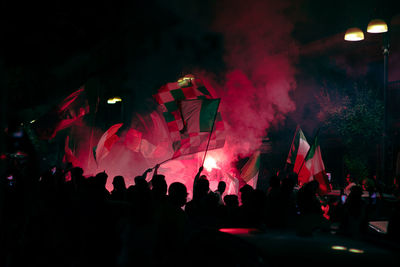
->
<box><xmin>154</xmin><ymin>76</ymin><xmax>225</xmax><ymax>158</ymax></box>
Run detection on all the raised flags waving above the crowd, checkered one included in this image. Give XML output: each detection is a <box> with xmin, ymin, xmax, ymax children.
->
<box><xmin>28</xmin><ymin>76</ymin><xmax>331</xmax><ymax>193</ymax></box>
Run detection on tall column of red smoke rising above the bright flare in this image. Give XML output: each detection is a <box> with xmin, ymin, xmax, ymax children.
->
<box><xmin>209</xmin><ymin>1</ymin><xmax>297</xmax><ymax>159</ymax></box>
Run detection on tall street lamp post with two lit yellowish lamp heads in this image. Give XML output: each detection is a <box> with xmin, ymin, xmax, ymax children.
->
<box><xmin>344</xmin><ymin>19</ymin><xmax>390</xmax><ymax>182</ymax></box>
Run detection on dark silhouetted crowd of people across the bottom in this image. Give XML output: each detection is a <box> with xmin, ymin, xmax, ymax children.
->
<box><xmin>0</xmin><ymin>162</ymin><xmax>400</xmax><ymax>266</ymax></box>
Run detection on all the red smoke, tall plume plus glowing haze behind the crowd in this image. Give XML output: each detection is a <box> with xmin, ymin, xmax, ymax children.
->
<box><xmin>70</xmin><ymin>0</ymin><xmax>297</xmax><ymax>197</ymax></box>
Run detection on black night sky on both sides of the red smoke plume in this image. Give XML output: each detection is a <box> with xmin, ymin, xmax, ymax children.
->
<box><xmin>3</xmin><ymin>0</ymin><xmax>399</xmax><ymax>111</ymax></box>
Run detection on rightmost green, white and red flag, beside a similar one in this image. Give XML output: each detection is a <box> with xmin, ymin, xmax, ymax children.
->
<box><xmin>303</xmin><ymin>135</ymin><xmax>331</xmax><ymax>193</ymax></box>
